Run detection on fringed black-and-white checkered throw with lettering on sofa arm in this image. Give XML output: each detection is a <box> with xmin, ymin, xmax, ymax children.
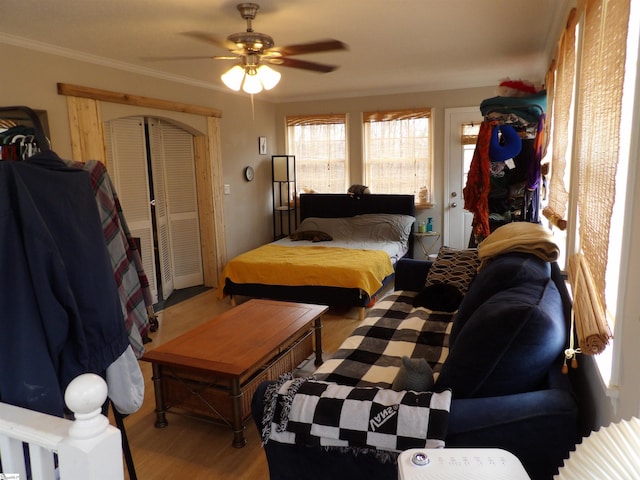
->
<box><xmin>262</xmin><ymin>374</ymin><xmax>451</xmax><ymax>461</ymax></box>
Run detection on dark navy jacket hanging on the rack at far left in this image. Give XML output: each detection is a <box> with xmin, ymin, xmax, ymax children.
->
<box><xmin>0</xmin><ymin>151</ymin><xmax>129</xmax><ymax>416</ymax></box>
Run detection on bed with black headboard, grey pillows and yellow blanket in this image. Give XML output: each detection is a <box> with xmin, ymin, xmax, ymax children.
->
<box><xmin>219</xmin><ymin>193</ymin><xmax>415</xmax><ymax>316</ymax></box>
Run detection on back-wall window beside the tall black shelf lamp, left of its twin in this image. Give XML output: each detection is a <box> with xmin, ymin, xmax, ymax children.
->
<box><xmin>286</xmin><ymin>114</ymin><xmax>347</xmax><ymax>193</ymax></box>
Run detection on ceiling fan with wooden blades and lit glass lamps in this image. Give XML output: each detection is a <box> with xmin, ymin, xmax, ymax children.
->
<box><xmin>187</xmin><ymin>3</ymin><xmax>347</xmax><ymax>93</ymax></box>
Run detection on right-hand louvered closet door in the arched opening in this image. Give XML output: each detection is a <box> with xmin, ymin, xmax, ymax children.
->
<box><xmin>149</xmin><ymin>120</ymin><xmax>204</xmax><ymax>292</ymax></box>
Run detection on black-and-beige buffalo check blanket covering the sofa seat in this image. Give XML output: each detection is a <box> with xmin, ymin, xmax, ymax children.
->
<box><xmin>314</xmin><ymin>291</ymin><xmax>453</xmax><ymax>388</ymax></box>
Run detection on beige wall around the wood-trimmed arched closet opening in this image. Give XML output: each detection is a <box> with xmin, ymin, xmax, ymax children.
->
<box><xmin>0</xmin><ymin>44</ymin><xmax>275</xmax><ymax>257</ymax></box>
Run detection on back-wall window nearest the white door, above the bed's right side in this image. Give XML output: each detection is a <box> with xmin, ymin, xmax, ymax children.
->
<box><xmin>363</xmin><ymin>109</ymin><xmax>433</xmax><ymax>200</ymax></box>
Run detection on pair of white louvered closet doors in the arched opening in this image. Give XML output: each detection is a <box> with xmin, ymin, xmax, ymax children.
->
<box><xmin>105</xmin><ymin>117</ymin><xmax>204</xmax><ymax>303</ymax></box>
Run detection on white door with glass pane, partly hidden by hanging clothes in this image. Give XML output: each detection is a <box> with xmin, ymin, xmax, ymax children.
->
<box><xmin>442</xmin><ymin>106</ymin><xmax>483</xmax><ymax>248</ymax></box>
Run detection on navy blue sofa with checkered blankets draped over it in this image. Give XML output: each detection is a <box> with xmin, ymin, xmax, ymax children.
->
<box><xmin>252</xmin><ymin>253</ymin><xmax>595</xmax><ymax>480</ymax></box>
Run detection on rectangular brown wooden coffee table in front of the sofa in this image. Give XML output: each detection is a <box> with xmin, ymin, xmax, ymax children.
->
<box><xmin>142</xmin><ymin>299</ymin><xmax>328</xmax><ymax>447</ymax></box>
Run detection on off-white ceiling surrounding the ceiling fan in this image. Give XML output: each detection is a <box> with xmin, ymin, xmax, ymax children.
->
<box><xmin>0</xmin><ymin>0</ymin><xmax>571</xmax><ymax>102</ymax></box>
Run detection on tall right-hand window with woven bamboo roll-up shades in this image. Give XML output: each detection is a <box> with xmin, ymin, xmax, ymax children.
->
<box><xmin>544</xmin><ymin>0</ymin><xmax>639</xmax><ymax>383</ymax></box>
